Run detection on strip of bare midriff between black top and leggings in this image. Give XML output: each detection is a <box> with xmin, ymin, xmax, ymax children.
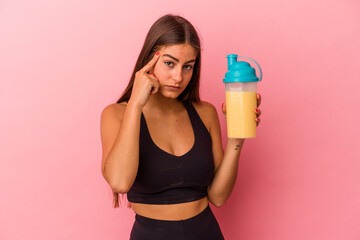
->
<box><xmin>130</xmin><ymin>197</ymin><xmax>209</xmax><ymax>220</ymax></box>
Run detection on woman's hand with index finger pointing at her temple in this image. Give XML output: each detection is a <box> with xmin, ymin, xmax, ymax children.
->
<box><xmin>129</xmin><ymin>52</ymin><xmax>160</xmax><ymax>109</ymax></box>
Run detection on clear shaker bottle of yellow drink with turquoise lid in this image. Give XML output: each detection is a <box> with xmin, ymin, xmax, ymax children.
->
<box><xmin>223</xmin><ymin>54</ymin><xmax>262</xmax><ymax>138</ymax></box>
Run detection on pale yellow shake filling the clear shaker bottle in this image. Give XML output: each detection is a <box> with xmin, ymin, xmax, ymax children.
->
<box><xmin>225</xmin><ymin>91</ymin><xmax>257</xmax><ymax>138</ymax></box>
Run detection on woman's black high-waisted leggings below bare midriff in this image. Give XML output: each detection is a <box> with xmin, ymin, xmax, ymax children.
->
<box><xmin>130</xmin><ymin>205</ymin><xmax>224</xmax><ymax>240</ymax></box>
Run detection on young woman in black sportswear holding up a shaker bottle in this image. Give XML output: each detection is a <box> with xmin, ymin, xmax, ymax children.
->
<box><xmin>101</xmin><ymin>15</ymin><xmax>261</xmax><ymax>240</ymax></box>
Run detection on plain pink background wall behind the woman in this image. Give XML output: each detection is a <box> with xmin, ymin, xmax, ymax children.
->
<box><xmin>0</xmin><ymin>0</ymin><xmax>360</xmax><ymax>240</ymax></box>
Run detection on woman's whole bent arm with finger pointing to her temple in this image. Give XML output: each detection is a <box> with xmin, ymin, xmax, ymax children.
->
<box><xmin>100</xmin><ymin>52</ymin><xmax>160</xmax><ymax>193</ymax></box>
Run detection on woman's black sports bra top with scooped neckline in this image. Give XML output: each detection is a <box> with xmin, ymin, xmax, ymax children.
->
<box><xmin>127</xmin><ymin>101</ymin><xmax>214</xmax><ymax>204</ymax></box>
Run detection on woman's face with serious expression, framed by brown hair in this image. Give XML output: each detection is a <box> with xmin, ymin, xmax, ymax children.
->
<box><xmin>152</xmin><ymin>43</ymin><xmax>196</xmax><ymax>98</ymax></box>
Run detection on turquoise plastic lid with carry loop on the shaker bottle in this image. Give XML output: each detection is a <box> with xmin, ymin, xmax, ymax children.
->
<box><xmin>223</xmin><ymin>54</ymin><xmax>262</xmax><ymax>83</ymax></box>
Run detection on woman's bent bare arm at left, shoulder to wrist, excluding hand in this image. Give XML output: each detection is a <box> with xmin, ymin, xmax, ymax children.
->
<box><xmin>100</xmin><ymin>103</ymin><xmax>141</xmax><ymax>193</ymax></box>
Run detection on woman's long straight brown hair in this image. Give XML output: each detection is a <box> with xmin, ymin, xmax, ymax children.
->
<box><xmin>113</xmin><ymin>14</ymin><xmax>201</xmax><ymax>208</ymax></box>
